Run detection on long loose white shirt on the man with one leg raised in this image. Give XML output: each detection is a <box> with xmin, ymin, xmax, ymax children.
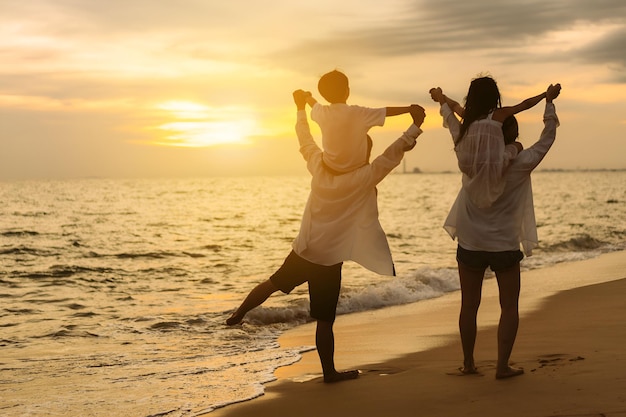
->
<box><xmin>293</xmin><ymin>110</ymin><xmax>422</xmax><ymax>275</ymax></box>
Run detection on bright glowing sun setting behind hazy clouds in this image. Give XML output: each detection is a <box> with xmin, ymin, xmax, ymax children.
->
<box><xmin>154</xmin><ymin>101</ymin><xmax>257</xmax><ymax>147</ymax></box>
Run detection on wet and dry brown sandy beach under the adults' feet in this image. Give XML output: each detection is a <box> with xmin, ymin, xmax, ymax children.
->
<box><xmin>211</xmin><ymin>252</ymin><xmax>626</xmax><ymax>417</ymax></box>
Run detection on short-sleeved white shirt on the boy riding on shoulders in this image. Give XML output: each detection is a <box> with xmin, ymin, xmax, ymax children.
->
<box><xmin>311</xmin><ymin>103</ymin><xmax>387</xmax><ymax>172</ymax></box>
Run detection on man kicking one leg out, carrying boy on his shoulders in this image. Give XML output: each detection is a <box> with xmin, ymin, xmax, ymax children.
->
<box><xmin>226</xmin><ymin>90</ymin><xmax>425</xmax><ymax>383</ymax></box>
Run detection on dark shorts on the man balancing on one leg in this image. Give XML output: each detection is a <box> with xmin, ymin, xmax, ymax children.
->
<box><xmin>270</xmin><ymin>251</ymin><xmax>343</xmax><ymax>323</ymax></box>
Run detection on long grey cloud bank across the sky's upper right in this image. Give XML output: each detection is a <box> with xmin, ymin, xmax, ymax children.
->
<box><xmin>271</xmin><ymin>0</ymin><xmax>626</xmax><ymax>77</ymax></box>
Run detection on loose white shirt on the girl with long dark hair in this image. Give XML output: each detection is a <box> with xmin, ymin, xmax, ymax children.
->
<box><xmin>444</xmin><ymin>107</ymin><xmax>517</xmax><ymax>207</ymax></box>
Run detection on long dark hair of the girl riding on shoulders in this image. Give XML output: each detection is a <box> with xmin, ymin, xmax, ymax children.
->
<box><xmin>454</xmin><ymin>76</ymin><xmax>502</xmax><ymax>145</ymax></box>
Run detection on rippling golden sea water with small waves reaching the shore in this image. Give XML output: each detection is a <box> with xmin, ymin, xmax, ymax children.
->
<box><xmin>0</xmin><ymin>171</ymin><xmax>626</xmax><ymax>416</ymax></box>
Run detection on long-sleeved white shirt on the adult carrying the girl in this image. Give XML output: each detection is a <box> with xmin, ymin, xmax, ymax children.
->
<box><xmin>441</xmin><ymin>103</ymin><xmax>559</xmax><ymax>256</ymax></box>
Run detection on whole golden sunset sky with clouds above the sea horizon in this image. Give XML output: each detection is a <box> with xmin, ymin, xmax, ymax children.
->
<box><xmin>0</xmin><ymin>0</ymin><xmax>626</xmax><ymax>180</ymax></box>
